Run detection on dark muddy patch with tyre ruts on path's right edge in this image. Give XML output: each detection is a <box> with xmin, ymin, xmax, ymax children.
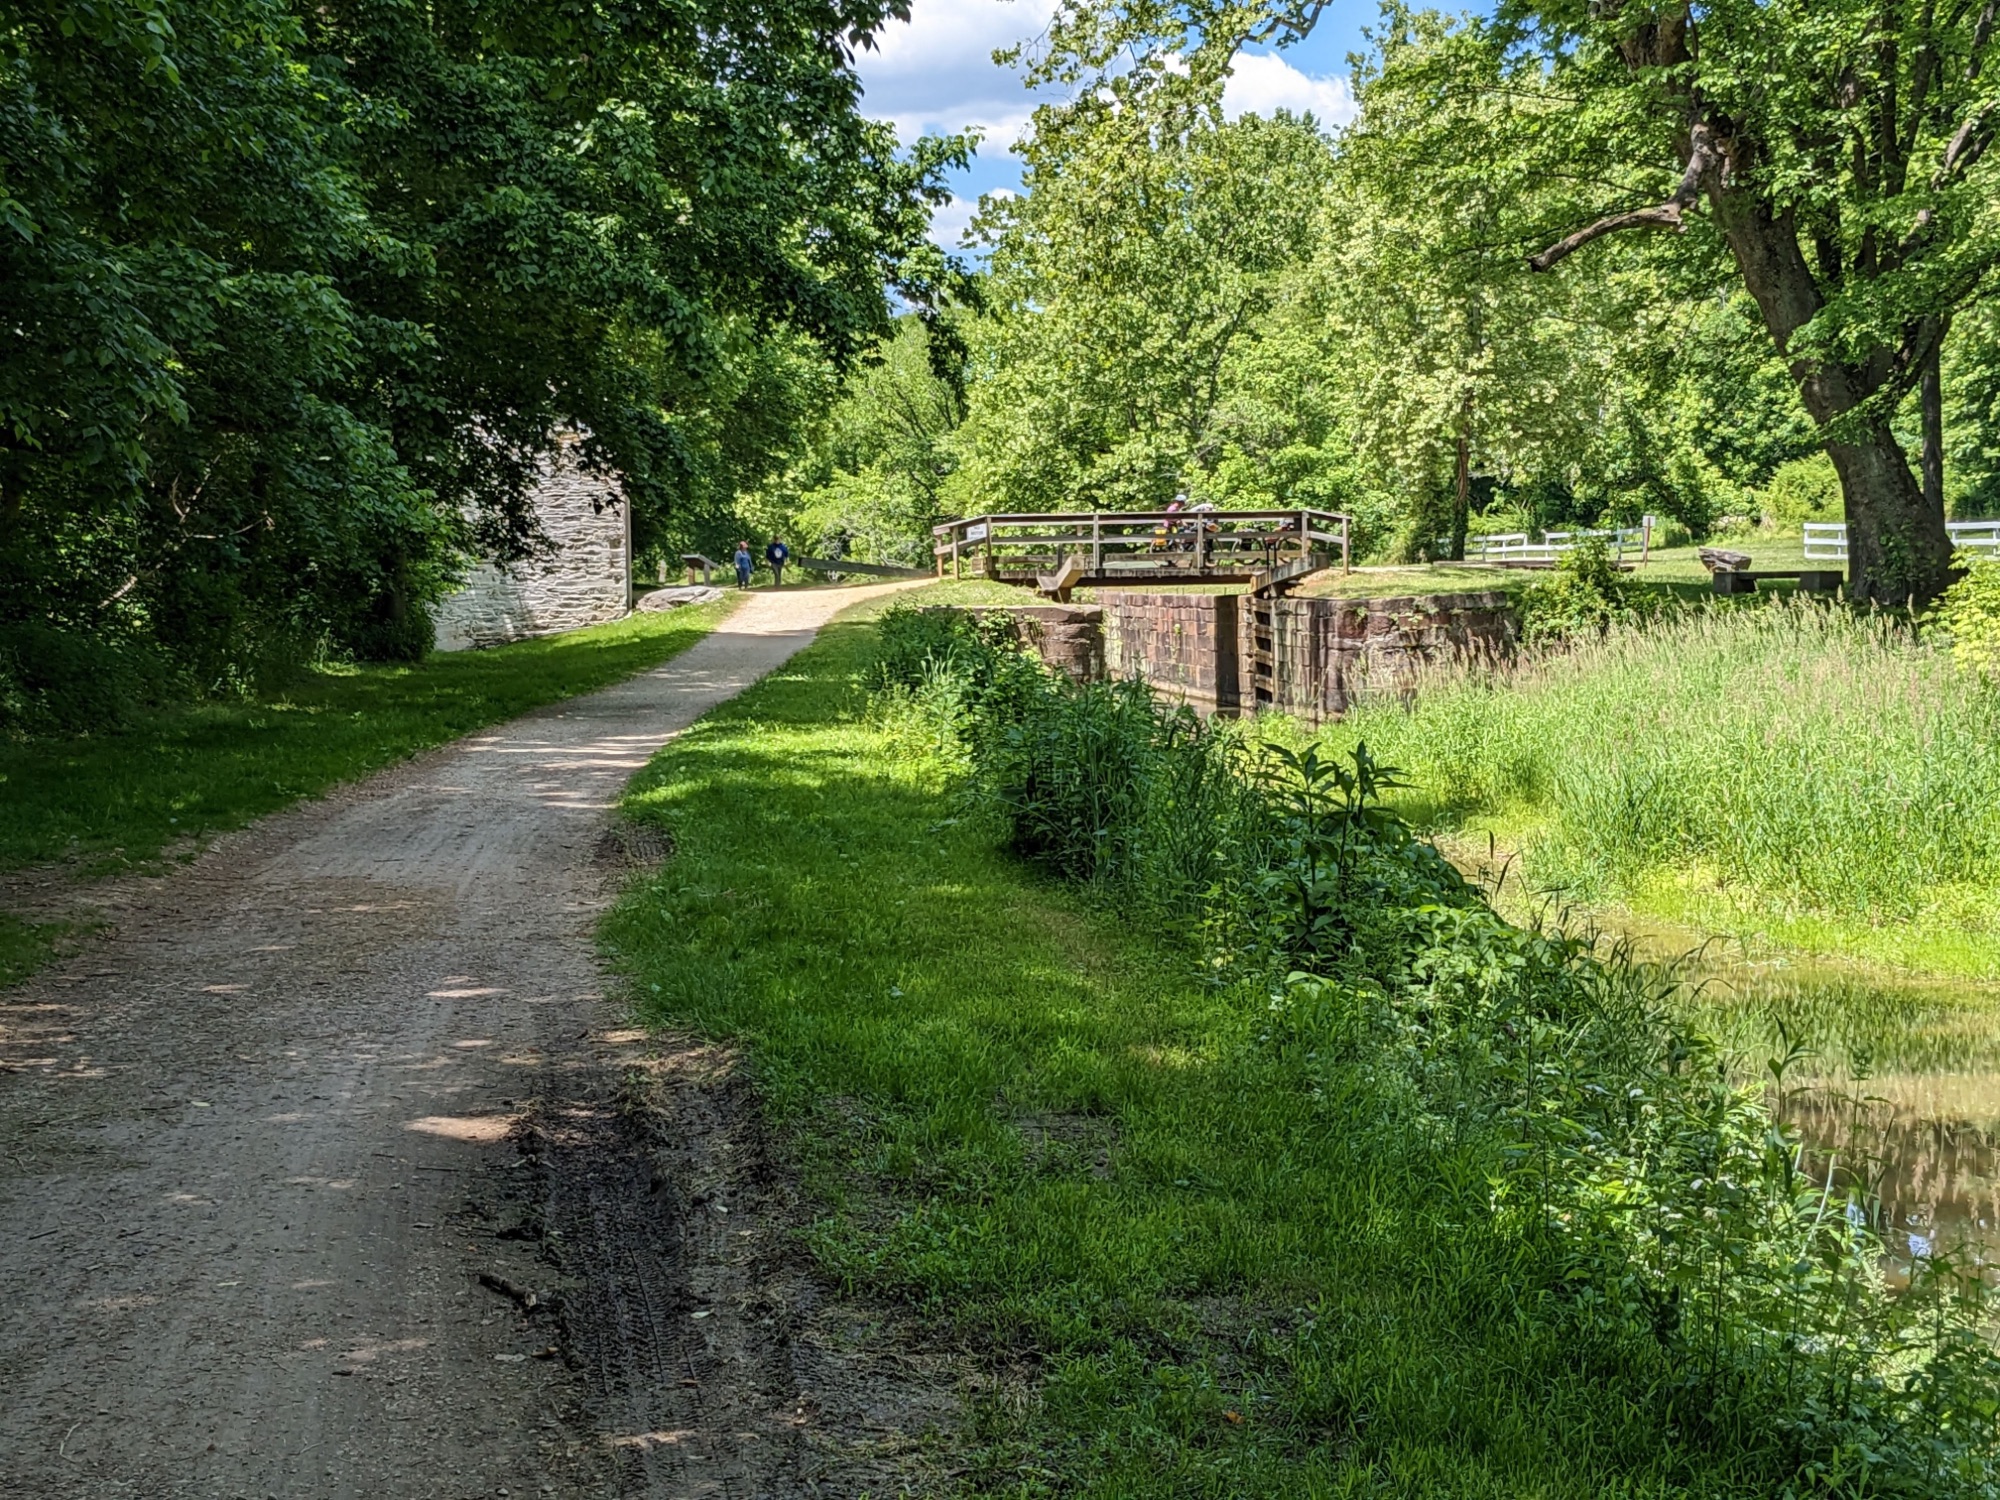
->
<box><xmin>516</xmin><ymin>1032</ymin><xmax>970</xmax><ymax>1496</ymax></box>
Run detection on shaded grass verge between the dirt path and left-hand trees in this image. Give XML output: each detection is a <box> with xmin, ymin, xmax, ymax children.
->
<box><xmin>0</xmin><ymin>606</ymin><xmax>726</xmax><ymax>880</ymax></box>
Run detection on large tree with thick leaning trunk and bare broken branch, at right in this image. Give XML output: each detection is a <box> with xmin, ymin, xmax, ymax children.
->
<box><xmin>1500</xmin><ymin>0</ymin><xmax>2000</xmax><ymax>602</ymax></box>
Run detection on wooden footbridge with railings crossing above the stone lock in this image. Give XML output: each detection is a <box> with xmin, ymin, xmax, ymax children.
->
<box><xmin>932</xmin><ymin>510</ymin><xmax>1352</xmax><ymax>600</ymax></box>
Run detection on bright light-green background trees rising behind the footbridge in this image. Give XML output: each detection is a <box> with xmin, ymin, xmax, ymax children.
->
<box><xmin>784</xmin><ymin>4</ymin><xmax>1840</xmax><ymax>556</ymax></box>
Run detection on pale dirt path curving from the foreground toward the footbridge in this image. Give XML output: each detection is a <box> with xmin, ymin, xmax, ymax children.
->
<box><xmin>0</xmin><ymin>590</ymin><xmax>920</xmax><ymax>1500</ymax></box>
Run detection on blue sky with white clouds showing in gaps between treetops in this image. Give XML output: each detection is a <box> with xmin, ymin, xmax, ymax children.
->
<box><xmin>858</xmin><ymin>0</ymin><xmax>1378</xmax><ymax>246</ymax></box>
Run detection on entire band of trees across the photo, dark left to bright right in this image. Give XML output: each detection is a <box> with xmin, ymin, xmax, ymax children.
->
<box><xmin>23</xmin><ymin>0</ymin><xmax>2000</xmax><ymax>728</ymax></box>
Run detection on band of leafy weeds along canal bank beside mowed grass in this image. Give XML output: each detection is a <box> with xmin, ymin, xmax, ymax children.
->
<box><xmin>868</xmin><ymin>624</ymin><xmax>2000</xmax><ymax>1494</ymax></box>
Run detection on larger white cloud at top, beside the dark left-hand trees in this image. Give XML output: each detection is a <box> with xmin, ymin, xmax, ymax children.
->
<box><xmin>856</xmin><ymin>0</ymin><xmax>1054</xmax><ymax>154</ymax></box>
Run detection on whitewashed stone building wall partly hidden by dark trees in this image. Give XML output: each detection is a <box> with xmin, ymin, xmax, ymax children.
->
<box><xmin>438</xmin><ymin>440</ymin><xmax>632</xmax><ymax>652</ymax></box>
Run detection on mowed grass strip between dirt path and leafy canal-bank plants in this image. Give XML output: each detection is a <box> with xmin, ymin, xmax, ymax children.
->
<box><xmin>604</xmin><ymin>604</ymin><xmax>1784</xmax><ymax>1498</ymax></box>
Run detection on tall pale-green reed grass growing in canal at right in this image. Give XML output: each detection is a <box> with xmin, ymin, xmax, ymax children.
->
<box><xmin>1324</xmin><ymin>602</ymin><xmax>2000</xmax><ymax>926</ymax></box>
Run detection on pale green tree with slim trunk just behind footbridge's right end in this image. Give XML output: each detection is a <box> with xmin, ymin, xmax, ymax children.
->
<box><xmin>1316</xmin><ymin>6</ymin><xmax>1632</xmax><ymax>558</ymax></box>
